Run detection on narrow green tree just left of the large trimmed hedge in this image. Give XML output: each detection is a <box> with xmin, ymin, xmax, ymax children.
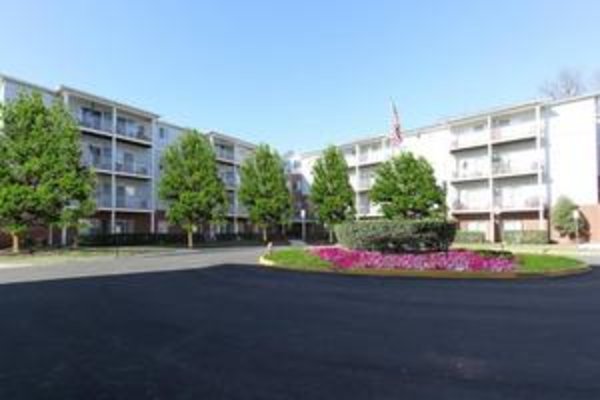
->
<box><xmin>310</xmin><ymin>146</ymin><xmax>354</xmax><ymax>242</ymax></box>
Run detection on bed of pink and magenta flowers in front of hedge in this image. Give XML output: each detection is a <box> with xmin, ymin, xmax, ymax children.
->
<box><xmin>311</xmin><ymin>247</ymin><xmax>515</xmax><ymax>272</ymax></box>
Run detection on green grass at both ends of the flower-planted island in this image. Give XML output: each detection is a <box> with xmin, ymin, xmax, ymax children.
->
<box><xmin>266</xmin><ymin>247</ymin><xmax>586</xmax><ymax>273</ymax></box>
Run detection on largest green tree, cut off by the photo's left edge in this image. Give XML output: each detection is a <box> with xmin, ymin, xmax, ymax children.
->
<box><xmin>0</xmin><ymin>92</ymin><xmax>94</xmax><ymax>252</ymax></box>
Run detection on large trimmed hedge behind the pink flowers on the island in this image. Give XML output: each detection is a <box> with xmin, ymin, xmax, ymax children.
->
<box><xmin>335</xmin><ymin>219</ymin><xmax>456</xmax><ymax>252</ymax></box>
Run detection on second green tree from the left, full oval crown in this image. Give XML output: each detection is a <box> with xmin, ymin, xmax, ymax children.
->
<box><xmin>159</xmin><ymin>130</ymin><xmax>227</xmax><ymax>248</ymax></box>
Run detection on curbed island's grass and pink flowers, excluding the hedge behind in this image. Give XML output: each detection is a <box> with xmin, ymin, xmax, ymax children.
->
<box><xmin>262</xmin><ymin>246</ymin><xmax>588</xmax><ymax>278</ymax></box>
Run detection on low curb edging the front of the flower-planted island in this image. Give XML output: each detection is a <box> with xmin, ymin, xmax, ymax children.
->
<box><xmin>258</xmin><ymin>255</ymin><xmax>592</xmax><ymax>280</ymax></box>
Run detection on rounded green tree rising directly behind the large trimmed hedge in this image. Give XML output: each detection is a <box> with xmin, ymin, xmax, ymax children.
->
<box><xmin>369</xmin><ymin>152</ymin><xmax>446</xmax><ymax>219</ymax></box>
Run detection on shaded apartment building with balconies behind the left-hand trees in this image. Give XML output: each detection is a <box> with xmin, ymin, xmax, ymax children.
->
<box><xmin>0</xmin><ymin>75</ymin><xmax>255</xmax><ymax>238</ymax></box>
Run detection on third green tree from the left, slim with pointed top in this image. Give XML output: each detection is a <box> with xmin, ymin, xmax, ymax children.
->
<box><xmin>239</xmin><ymin>144</ymin><xmax>292</xmax><ymax>242</ymax></box>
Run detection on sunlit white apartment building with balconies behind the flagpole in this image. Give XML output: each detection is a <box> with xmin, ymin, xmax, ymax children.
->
<box><xmin>290</xmin><ymin>94</ymin><xmax>600</xmax><ymax>241</ymax></box>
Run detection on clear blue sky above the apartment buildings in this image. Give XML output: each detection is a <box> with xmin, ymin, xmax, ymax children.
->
<box><xmin>0</xmin><ymin>0</ymin><xmax>600</xmax><ymax>151</ymax></box>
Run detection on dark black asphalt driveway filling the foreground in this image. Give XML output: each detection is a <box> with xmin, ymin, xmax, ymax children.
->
<box><xmin>0</xmin><ymin>265</ymin><xmax>600</xmax><ymax>400</ymax></box>
